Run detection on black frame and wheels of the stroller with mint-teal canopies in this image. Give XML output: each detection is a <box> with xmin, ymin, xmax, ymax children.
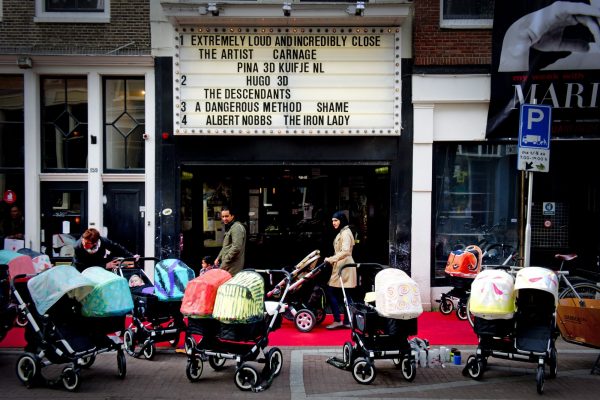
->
<box><xmin>11</xmin><ymin>274</ymin><xmax>127</xmax><ymax>391</ymax></box>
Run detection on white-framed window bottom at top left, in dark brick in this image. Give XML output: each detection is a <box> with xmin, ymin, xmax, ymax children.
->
<box><xmin>34</xmin><ymin>0</ymin><xmax>110</xmax><ymax>23</ymax></box>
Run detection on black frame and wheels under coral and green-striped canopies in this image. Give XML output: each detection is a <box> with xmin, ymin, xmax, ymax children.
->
<box><xmin>185</xmin><ymin>269</ymin><xmax>291</xmax><ymax>392</ymax></box>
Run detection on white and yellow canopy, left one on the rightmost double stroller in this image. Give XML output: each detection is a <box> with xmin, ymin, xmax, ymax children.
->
<box><xmin>469</xmin><ymin>269</ymin><xmax>515</xmax><ymax>319</ymax></box>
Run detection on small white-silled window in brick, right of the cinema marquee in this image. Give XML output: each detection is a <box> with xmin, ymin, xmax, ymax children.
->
<box><xmin>440</xmin><ymin>0</ymin><xmax>494</xmax><ymax>29</ymax></box>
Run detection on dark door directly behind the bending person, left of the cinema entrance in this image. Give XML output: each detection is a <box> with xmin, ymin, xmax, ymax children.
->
<box><xmin>104</xmin><ymin>182</ymin><xmax>145</xmax><ymax>255</ymax></box>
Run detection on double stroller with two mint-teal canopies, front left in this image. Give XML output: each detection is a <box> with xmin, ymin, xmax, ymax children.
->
<box><xmin>11</xmin><ymin>265</ymin><xmax>133</xmax><ymax>391</ymax></box>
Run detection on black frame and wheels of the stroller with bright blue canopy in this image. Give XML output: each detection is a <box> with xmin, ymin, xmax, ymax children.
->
<box><xmin>114</xmin><ymin>257</ymin><xmax>186</xmax><ymax>360</ymax></box>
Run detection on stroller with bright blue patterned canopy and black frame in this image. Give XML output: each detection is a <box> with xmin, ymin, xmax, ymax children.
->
<box><xmin>116</xmin><ymin>257</ymin><xmax>194</xmax><ymax>360</ymax></box>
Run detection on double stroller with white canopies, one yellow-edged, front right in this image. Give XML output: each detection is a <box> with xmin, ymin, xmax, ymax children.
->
<box><xmin>463</xmin><ymin>267</ymin><xmax>558</xmax><ymax>394</ymax></box>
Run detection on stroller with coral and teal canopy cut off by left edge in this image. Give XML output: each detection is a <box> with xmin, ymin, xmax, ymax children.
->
<box><xmin>0</xmin><ymin>250</ymin><xmax>37</xmax><ymax>341</ymax></box>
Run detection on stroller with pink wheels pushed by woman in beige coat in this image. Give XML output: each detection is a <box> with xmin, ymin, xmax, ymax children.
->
<box><xmin>267</xmin><ymin>250</ymin><xmax>327</xmax><ymax>332</ymax></box>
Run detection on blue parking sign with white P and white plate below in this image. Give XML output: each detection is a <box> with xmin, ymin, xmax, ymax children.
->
<box><xmin>517</xmin><ymin>104</ymin><xmax>552</xmax><ymax>172</ymax></box>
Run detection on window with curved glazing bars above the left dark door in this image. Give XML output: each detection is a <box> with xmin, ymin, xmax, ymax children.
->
<box><xmin>41</xmin><ymin>77</ymin><xmax>88</xmax><ymax>172</ymax></box>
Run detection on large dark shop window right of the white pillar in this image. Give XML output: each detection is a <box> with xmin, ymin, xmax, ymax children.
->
<box><xmin>433</xmin><ymin>143</ymin><xmax>518</xmax><ymax>278</ymax></box>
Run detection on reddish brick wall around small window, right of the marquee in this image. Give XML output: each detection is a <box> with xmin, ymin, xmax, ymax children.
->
<box><xmin>413</xmin><ymin>0</ymin><xmax>492</xmax><ymax>66</ymax></box>
